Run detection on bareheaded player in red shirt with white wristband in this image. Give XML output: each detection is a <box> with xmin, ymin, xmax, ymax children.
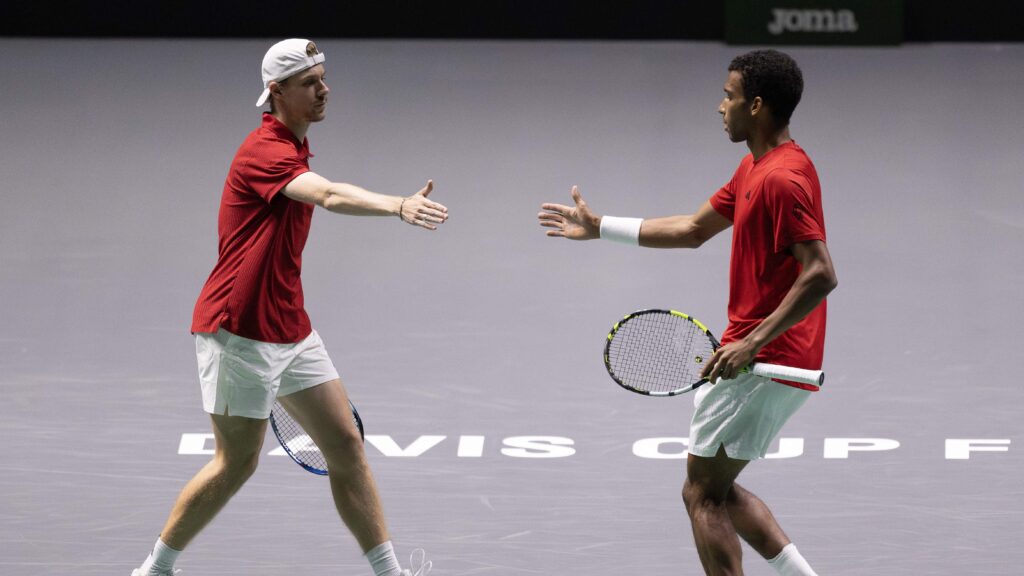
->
<box><xmin>539</xmin><ymin>50</ymin><xmax>837</xmax><ymax>576</ymax></box>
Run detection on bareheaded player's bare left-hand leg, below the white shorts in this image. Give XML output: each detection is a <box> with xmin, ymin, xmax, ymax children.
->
<box><xmin>683</xmin><ymin>447</ymin><xmax>748</xmax><ymax>576</ymax></box>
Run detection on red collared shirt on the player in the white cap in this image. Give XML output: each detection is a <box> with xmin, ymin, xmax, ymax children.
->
<box><xmin>191</xmin><ymin>114</ymin><xmax>313</xmax><ymax>343</ymax></box>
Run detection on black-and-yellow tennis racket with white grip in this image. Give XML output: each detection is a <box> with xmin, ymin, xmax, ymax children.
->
<box><xmin>604</xmin><ymin>310</ymin><xmax>825</xmax><ymax>396</ymax></box>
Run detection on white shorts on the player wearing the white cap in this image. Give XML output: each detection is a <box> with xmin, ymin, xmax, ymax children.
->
<box><xmin>196</xmin><ymin>328</ymin><xmax>338</xmax><ymax>419</ymax></box>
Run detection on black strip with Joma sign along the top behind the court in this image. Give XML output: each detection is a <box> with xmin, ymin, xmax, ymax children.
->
<box><xmin>0</xmin><ymin>0</ymin><xmax>1024</xmax><ymax>44</ymax></box>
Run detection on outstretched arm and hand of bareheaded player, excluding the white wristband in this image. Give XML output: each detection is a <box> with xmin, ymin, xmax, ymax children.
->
<box><xmin>538</xmin><ymin>187</ymin><xmax>732</xmax><ymax>248</ymax></box>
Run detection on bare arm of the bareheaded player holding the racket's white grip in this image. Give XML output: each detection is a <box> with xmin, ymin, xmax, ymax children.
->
<box><xmin>701</xmin><ymin>240</ymin><xmax>839</xmax><ymax>379</ymax></box>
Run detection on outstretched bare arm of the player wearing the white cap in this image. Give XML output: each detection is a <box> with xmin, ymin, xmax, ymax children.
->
<box><xmin>282</xmin><ymin>172</ymin><xmax>447</xmax><ymax>230</ymax></box>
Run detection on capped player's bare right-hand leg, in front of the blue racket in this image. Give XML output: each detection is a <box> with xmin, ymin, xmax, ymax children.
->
<box><xmin>278</xmin><ymin>379</ymin><xmax>388</xmax><ymax>552</ymax></box>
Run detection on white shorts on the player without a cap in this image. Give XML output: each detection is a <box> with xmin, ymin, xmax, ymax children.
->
<box><xmin>689</xmin><ymin>374</ymin><xmax>812</xmax><ymax>460</ymax></box>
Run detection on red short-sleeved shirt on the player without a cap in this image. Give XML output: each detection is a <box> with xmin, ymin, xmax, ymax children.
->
<box><xmin>710</xmin><ymin>141</ymin><xmax>826</xmax><ymax>387</ymax></box>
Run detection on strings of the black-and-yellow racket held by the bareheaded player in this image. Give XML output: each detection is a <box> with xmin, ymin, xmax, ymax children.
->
<box><xmin>608</xmin><ymin>314</ymin><xmax>715</xmax><ymax>393</ymax></box>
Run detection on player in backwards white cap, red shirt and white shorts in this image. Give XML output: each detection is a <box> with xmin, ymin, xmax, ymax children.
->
<box><xmin>132</xmin><ymin>38</ymin><xmax>447</xmax><ymax>576</ymax></box>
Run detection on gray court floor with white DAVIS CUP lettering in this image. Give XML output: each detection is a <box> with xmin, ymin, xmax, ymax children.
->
<box><xmin>0</xmin><ymin>39</ymin><xmax>1024</xmax><ymax>576</ymax></box>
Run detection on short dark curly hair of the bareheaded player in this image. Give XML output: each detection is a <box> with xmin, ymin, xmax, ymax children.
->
<box><xmin>729</xmin><ymin>50</ymin><xmax>804</xmax><ymax>125</ymax></box>
